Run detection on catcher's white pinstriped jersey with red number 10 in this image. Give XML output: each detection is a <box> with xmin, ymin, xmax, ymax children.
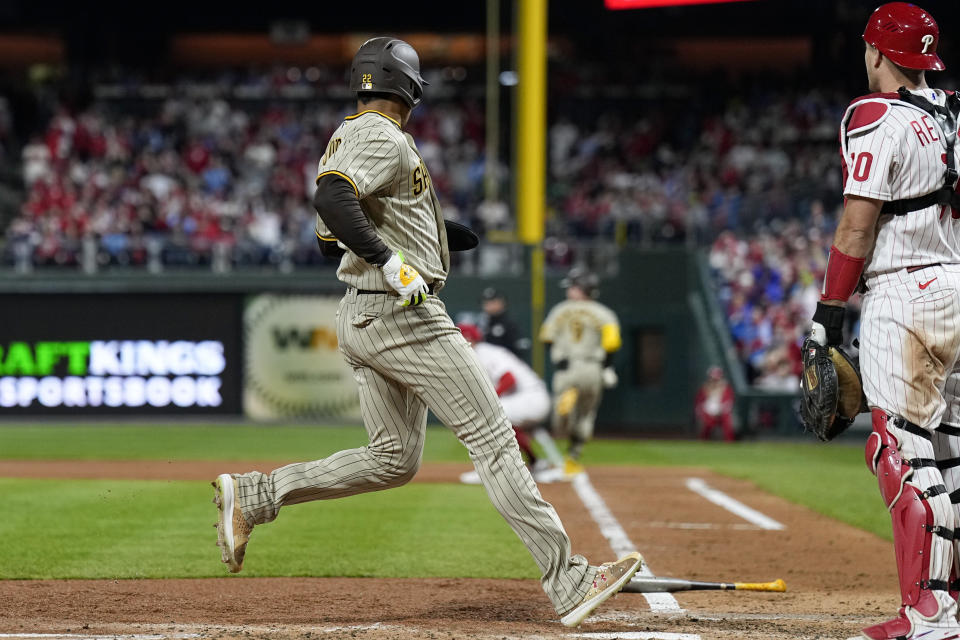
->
<box><xmin>840</xmin><ymin>89</ymin><xmax>960</xmax><ymax>276</ymax></box>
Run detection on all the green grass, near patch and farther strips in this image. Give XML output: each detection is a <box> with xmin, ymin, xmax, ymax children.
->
<box><xmin>0</xmin><ymin>425</ymin><xmax>890</xmax><ymax>578</ymax></box>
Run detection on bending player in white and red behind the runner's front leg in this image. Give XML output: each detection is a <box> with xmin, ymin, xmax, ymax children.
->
<box><xmin>457</xmin><ymin>322</ymin><xmax>563</xmax><ymax>484</ymax></box>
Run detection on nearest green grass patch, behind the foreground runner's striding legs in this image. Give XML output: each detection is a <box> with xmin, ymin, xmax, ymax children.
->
<box><xmin>0</xmin><ymin>479</ymin><xmax>537</xmax><ymax>579</ymax></box>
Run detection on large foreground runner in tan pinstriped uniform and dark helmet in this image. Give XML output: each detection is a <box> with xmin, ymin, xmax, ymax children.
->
<box><xmin>214</xmin><ymin>38</ymin><xmax>642</xmax><ymax>626</ymax></box>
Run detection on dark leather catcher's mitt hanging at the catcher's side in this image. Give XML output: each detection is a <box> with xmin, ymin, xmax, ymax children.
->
<box><xmin>800</xmin><ymin>337</ymin><xmax>868</xmax><ymax>441</ymax></box>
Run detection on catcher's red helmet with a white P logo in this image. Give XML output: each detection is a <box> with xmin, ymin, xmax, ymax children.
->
<box><xmin>863</xmin><ymin>2</ymin><xmax>946</xmax><ymax>71</ymax></box>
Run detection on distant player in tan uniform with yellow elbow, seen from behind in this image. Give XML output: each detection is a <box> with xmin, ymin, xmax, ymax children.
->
<box><xmin>540</xmin><ymin>267</ymin><xmax>620</xmax><ymax>474</ymax></box>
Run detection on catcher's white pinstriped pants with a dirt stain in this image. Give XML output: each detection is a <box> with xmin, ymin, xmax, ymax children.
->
<box><xmin>860</xmin><ymin>265</ymin><xmax>960</xmax><ymax>617</ymax></box>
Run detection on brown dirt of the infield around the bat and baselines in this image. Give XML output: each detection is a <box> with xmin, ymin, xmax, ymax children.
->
<box><xmin>0</xmin><ymin>461</ymin><xmax>899</xmax><ymax>640</ymax></box>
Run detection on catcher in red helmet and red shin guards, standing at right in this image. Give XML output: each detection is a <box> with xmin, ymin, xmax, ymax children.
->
<box><xmin>811</xmin><ymin>2</ymin><xmax>960</xmax><ymax>640</ymax></box>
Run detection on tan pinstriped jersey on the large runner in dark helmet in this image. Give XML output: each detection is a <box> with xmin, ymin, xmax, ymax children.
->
<box><xmin>317</xmin><ymin>111</ymin><xmax>450</xmax><ymax>291</ymax></box>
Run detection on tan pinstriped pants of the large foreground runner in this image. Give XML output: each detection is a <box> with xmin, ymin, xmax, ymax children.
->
<box><xmin>236</xmin><ymin>289</ymin><xmax>595</xmax><ymax>613</ymax></box>
